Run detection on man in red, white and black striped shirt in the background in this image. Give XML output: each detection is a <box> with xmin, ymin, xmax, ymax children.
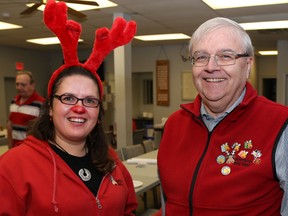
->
<box><xmin>7</xmin><ymin>71</ymin><xmax>45</xmax><ymax>148</ymax></box>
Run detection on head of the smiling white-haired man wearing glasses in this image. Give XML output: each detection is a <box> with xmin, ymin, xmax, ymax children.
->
<box><xmin>189</xmin><ymin>17</ymin><xmax>254</xmax><ymax>116</ymax></box>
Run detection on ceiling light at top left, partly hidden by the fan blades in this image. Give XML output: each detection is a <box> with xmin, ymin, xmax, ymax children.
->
<box><xmin>26</xmin><ymin>0</ymin><xmax>117</xmax><ymax>11</ymax></box>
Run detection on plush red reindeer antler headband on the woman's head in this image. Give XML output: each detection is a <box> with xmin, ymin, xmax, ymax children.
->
<box><xmin>44</xmin><ymin>0</ymin><xmax>136</xmax><ymax>97</ymax></box>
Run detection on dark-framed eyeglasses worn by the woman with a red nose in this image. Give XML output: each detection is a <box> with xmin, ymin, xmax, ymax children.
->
<box><xmin>53</xmin><ymin>94</ymin><xmax>101</xmax><ymax>108</ymax></box>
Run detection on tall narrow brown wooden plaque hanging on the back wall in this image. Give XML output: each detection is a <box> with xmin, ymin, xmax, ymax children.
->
<box><xmin>156</xmin><ymin>60</ymin><xmax>169</xmax><ymax>106</ymax></box>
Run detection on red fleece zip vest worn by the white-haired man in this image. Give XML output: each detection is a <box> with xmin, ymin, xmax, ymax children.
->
<box><xmin>158</xmin><ymin>84</ymin><xmax>288</xmax><ymax>216</ymax></box>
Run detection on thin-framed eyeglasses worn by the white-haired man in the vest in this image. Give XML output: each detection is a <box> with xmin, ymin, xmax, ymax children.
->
<box><xmin>191</xmin><ymin>51</ymin><xmax>249</xmax><ymax>67</ymax></box>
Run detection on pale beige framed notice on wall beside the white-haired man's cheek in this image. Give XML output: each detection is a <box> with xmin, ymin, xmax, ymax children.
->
<box><xmin>182</xmin><ymin>71</ymin><xmax>197</xmax><ymax>101</ymax></box>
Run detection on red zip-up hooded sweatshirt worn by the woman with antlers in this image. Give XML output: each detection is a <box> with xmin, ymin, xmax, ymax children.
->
<box><xmin>0</xmin><ymin>136</ymin><xmax>137</xmax><ymax>216</ymax></box>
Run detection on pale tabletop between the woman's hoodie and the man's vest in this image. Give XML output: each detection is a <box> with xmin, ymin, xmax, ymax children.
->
<box><xmin>123</xmin><ymin>150</ymin><xmax>160</xmax><ymax>195</ymax></box>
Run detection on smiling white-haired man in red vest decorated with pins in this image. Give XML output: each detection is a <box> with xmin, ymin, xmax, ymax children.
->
<box><xmin>158</xmin><ymin>17</ymin><xmax>288</xmax><ymax>216</ymax></box>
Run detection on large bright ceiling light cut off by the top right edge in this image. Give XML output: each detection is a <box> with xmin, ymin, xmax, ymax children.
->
<box><xmin>203</xmin><ymin>0</ymin><xmax>288</xmax><ymax>10</ymax></box>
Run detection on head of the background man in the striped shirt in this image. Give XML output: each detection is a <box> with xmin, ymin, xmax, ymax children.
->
<box><xmin>15</xmin><ymin>71</ymin><xmax>35</xmax><ymax>99</ymax></box>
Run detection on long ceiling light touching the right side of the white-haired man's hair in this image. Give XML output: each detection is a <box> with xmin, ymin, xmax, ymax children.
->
<box><xmin>239</xmin><ymin>20</ymin><xmax>288</xmax><ymax>30</ymax></box>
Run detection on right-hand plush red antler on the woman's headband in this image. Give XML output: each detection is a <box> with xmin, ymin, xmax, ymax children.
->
<box><xmin>84</xmin><ymin>17</ymin><xmax>136</xmax><ymax>71</ymax></box>
